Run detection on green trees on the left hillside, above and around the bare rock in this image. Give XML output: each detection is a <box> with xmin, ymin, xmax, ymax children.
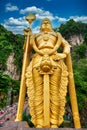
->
<box><xmin>0</xmin><ymin>25</ymin><xmax>24</xmax><ymax>71</ymax></box>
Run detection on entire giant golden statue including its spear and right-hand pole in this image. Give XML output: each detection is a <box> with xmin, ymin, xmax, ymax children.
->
<box><xmin>16</xmin><ymin>15</ymin><xmax>81</xmax><ymax>128</ymax></box>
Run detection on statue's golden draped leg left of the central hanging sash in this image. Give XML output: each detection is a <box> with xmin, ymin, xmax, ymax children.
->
<box><xmin>33</xmin><ymin>68</ymin><xmax>43</xmax><ymax>128</ymax></box>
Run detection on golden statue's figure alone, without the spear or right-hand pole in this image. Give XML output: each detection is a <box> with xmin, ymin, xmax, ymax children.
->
<box><xmin>26</xmin><ymin>18</ymin><xmax>70</xmax><ymax>128</ymax></box>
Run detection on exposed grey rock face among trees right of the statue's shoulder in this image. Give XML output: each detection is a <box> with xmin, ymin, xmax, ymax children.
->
<box><xmin>68</xmin><ymin>34</ymin><xmax>84</xmax><ymax>46</ymax></box>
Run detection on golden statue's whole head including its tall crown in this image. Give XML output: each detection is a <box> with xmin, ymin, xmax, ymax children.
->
<box><xmin>40</xmin><ymin>18</ymin><xmax>53</xmax><ymax>32</ymax></box>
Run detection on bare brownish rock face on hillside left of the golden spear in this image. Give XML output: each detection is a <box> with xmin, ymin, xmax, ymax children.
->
<box><xmin>4</xmin><ymin>53</ymin><xmax>20</xmax><ymax>80</ymax></box>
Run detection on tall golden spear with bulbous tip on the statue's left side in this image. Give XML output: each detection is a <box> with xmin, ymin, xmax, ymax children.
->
<box><xmin>15</xmin><ymin>14</ymin><xmax>36</xmax><ymax>121</ymax></box>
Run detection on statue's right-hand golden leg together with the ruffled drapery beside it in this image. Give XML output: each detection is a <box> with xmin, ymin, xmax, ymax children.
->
<box><xmin>50</xmin><ymin>61</ymin><xmax>68</xmax><ymax>127</ymax></box>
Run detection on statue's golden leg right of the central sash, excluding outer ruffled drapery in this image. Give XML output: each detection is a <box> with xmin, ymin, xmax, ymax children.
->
<box><xmin>50</xmin><ymin>68</ymin><xmax>61</xmax><ymax>128</ymax></box>
